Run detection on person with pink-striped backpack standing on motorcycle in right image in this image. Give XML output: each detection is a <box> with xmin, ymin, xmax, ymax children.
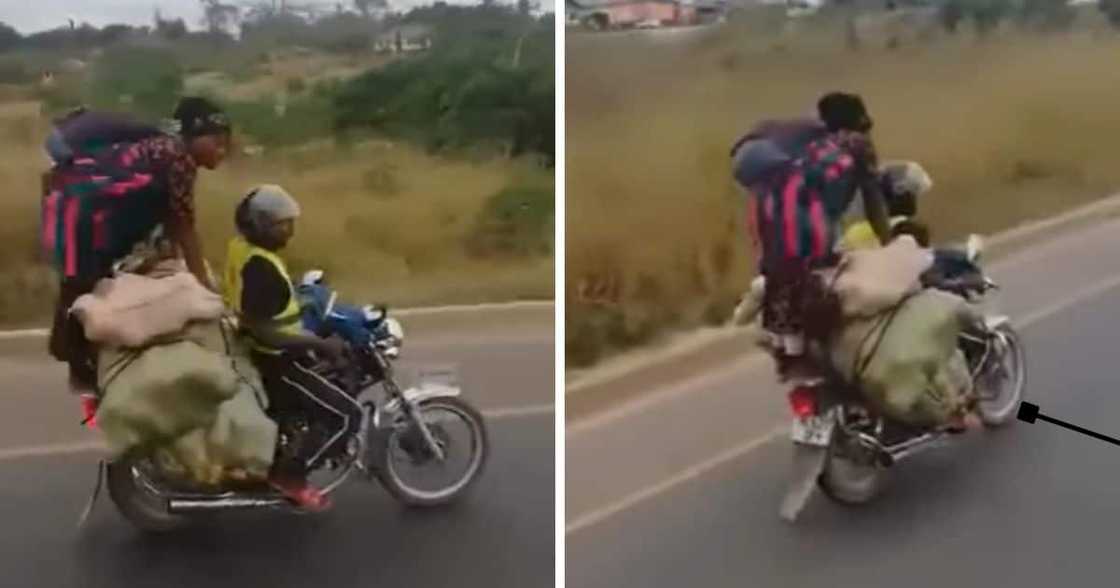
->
<box><xmin>732</xmin><ymin>92</ymin><xmax>889</xmax><ymax>379</ymax></box>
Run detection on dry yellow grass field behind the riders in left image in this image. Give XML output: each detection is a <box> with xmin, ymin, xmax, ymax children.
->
<box><xmin>0</xmin><ymin>98</ymin><xmax>553</xmax><ymax>325</ymax></box>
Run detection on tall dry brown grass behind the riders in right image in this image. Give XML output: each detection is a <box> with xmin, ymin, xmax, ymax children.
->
<box><xmin>566</xmin><ymin>26</ymin><xmax>1120</xmax><ymax>365</ymax></box>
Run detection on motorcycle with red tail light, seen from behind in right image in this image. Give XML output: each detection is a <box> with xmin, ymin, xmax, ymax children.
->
<box><xmin>780</xmin><ymin>236</ymin><xmax>1026</xmax><ymax>522</ymax></box>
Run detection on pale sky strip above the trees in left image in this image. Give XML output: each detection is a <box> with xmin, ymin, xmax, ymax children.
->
<box><xmin>0</xmin><ymin>0</ymin><xmax>556</xmax><ymax>34</ymax></box>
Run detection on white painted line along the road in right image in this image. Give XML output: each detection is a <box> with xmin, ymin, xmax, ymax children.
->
<box><xmin>564</xmin><ymin>276</ymin><xmax>1120</xmax><ymax>534</ymax></box>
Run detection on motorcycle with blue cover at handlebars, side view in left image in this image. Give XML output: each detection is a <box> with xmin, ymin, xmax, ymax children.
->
<box><xmin>83</xmin><ymin>271</ymin><xmax>489</xmax><ymax>532</ymax></box>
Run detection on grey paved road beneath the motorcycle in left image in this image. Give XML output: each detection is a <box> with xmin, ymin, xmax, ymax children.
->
<box><xmin>0</xmin><ymin>323</ymin><xmax>556</xmax><ymax>588</ymax></box>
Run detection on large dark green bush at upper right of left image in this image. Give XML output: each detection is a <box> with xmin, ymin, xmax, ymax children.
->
<box><xmin>335</xmin><ymin>13</ymin><xmax>556</xmax><ymax>161</ymax></box>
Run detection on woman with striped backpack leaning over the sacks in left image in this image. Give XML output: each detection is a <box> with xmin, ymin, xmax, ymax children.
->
<box><xmin>41</xmin><ymin>97</ymin><xmax>232</xmax><ymax>405</ymax></box>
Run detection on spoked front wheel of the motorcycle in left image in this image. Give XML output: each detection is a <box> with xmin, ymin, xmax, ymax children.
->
<box><xmin>371</xmin><ymin>398</ymin><xmax>489</xmax><ymax>507</ymax></box>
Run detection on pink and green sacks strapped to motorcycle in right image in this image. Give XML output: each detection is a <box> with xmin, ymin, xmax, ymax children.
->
<box><xmin>737</xmin><ymin>239</ymin><xmax>982</xmax><ymax>427</ymax></box>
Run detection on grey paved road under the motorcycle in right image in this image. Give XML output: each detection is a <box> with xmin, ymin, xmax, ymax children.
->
<box><xmin>567</xmin><ymin>222</ymin><xmax>1120</xmax><ymax>588</ymax></box>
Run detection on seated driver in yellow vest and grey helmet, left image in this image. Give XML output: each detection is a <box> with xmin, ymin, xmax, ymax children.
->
<box><xmin>223</xmin><ymin>185</ymin><xmax>361</xmax><ymax>511</ymax></box>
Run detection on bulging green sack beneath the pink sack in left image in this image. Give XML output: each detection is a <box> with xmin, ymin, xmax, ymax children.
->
<box><xmin>97</xmin><ymin>324</ymin><xmax>277</xmax><ymax>484</ymax></box>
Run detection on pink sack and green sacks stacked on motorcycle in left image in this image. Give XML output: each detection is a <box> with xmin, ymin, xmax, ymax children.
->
<box><xmin>72</xmin><ymin>262</ymin><xmax>277</xmax><ymax>485</ymax></box>
